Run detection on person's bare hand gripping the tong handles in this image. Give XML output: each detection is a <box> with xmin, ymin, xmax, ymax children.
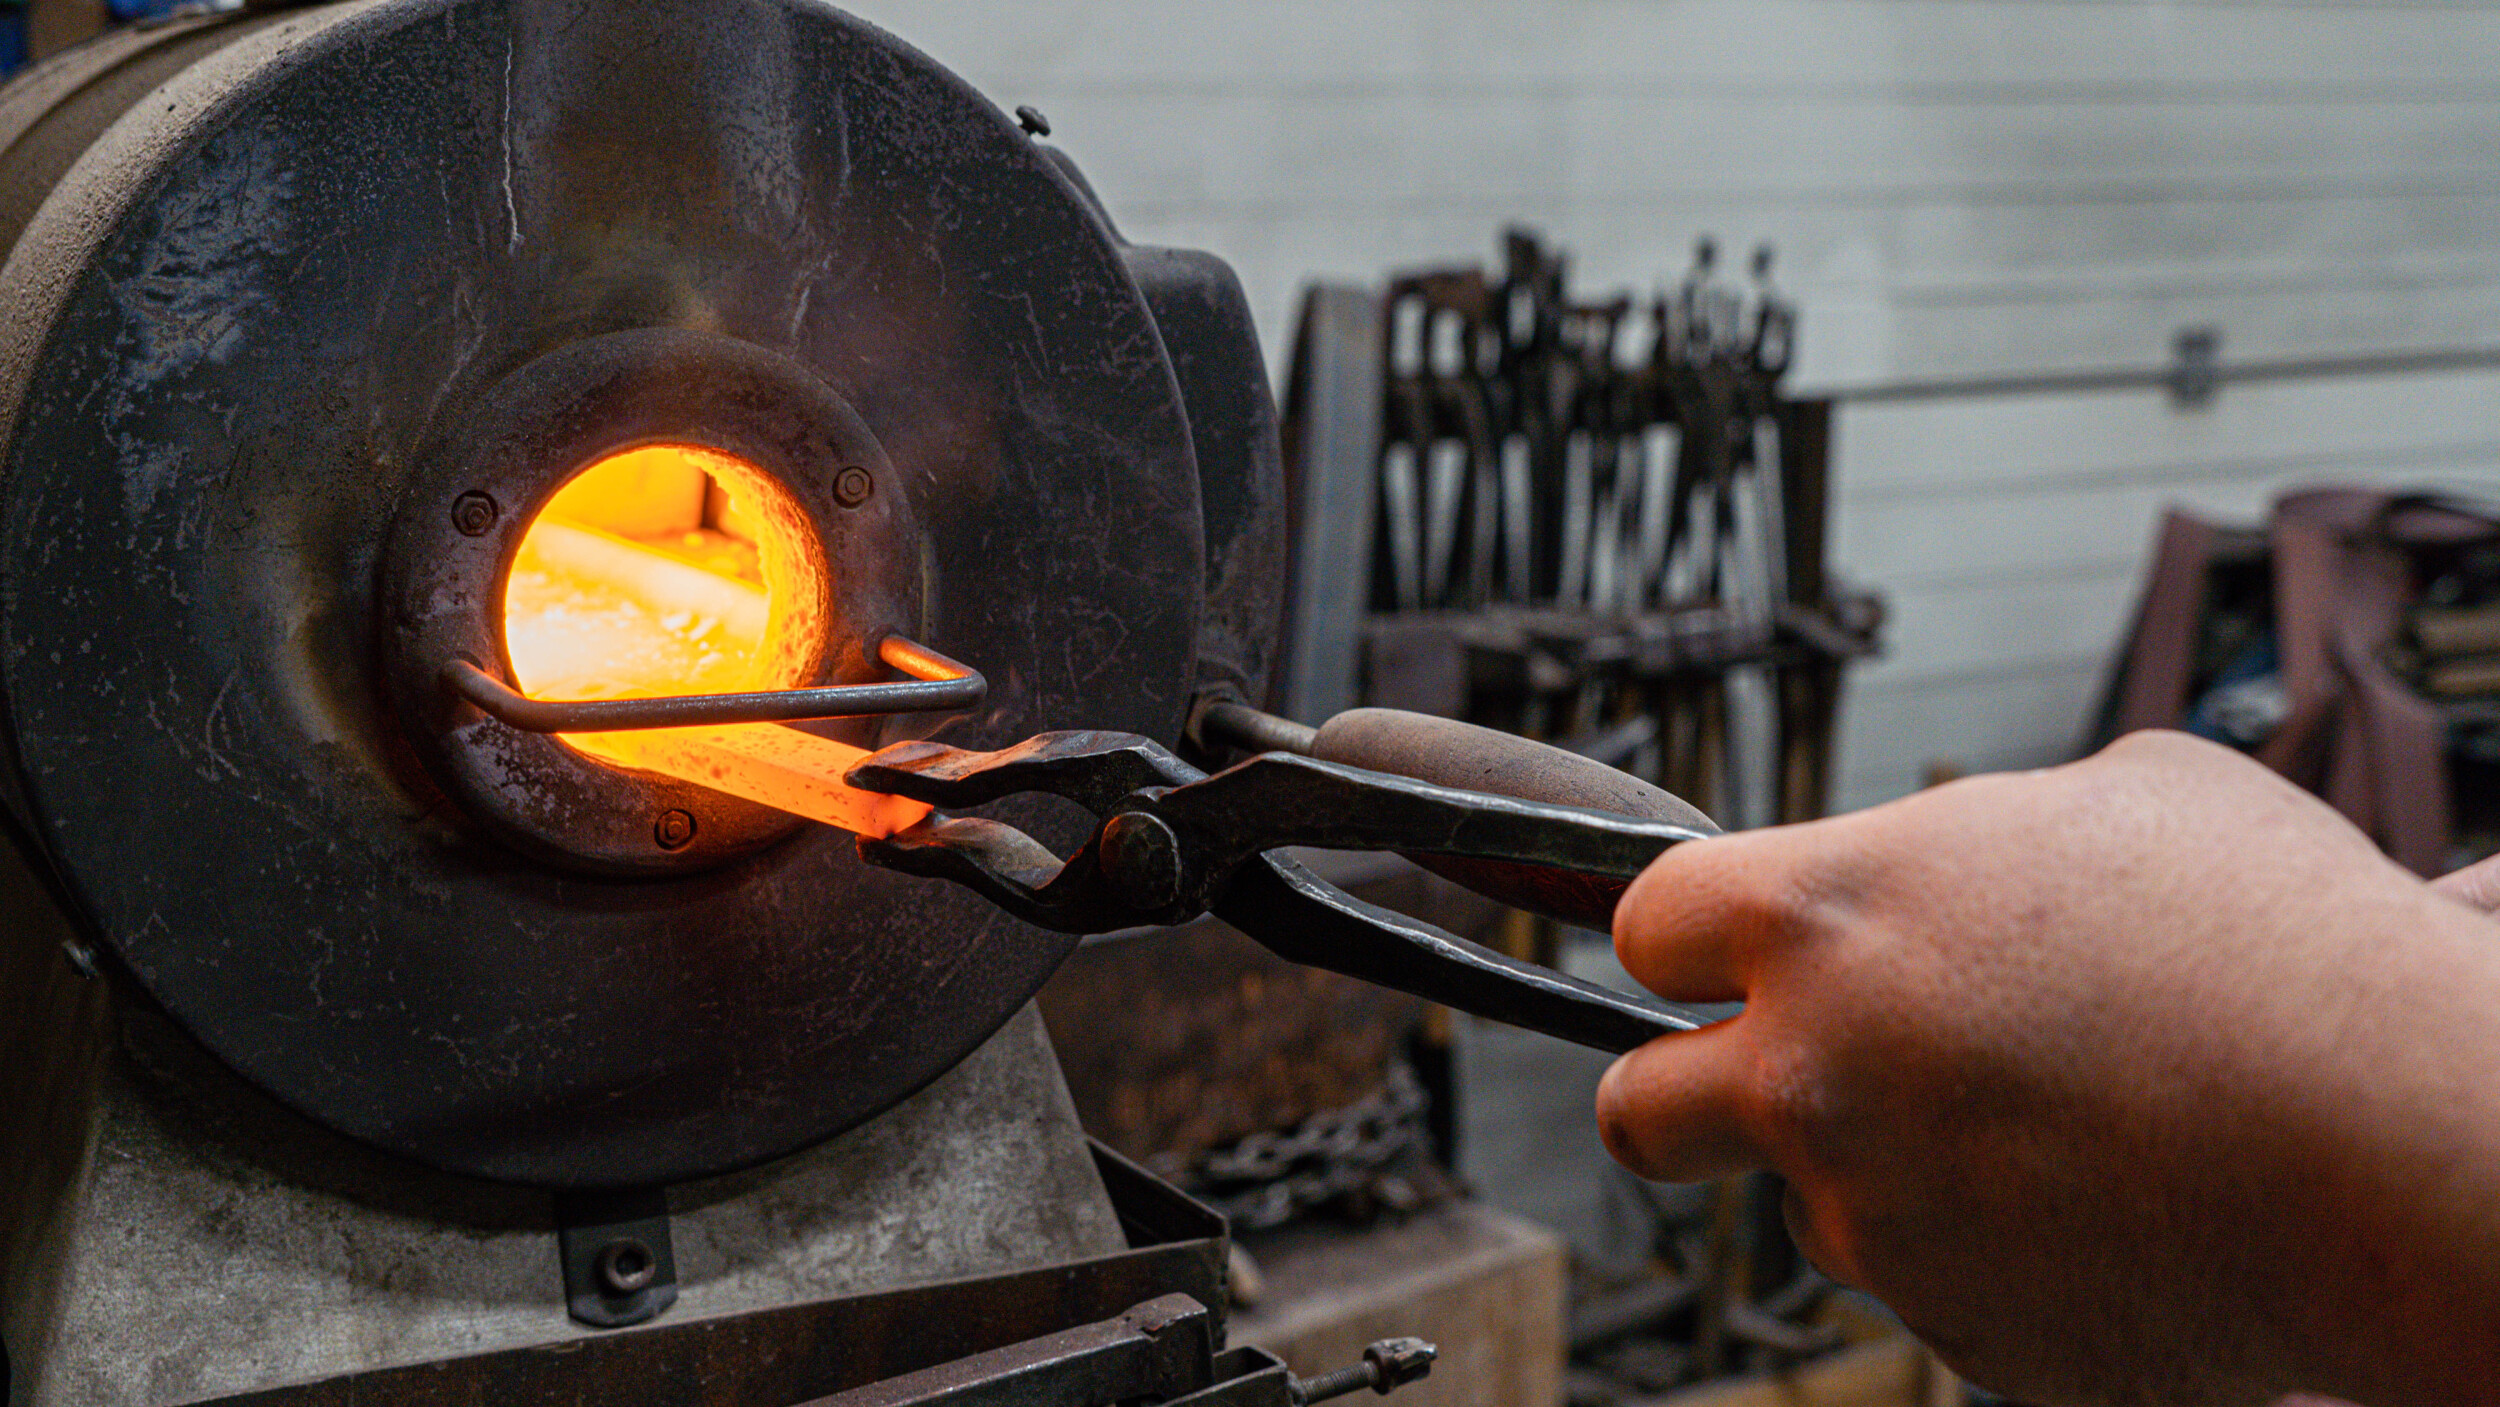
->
<box><xmin>1598</xmin><ymin>735</ymin><xmax>2500</xmax><ymax>1405</ymax></box>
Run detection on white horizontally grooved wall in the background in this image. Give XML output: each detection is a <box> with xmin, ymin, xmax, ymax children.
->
<box><xmin>858</xmin><ymin>0</ymin><xmax>2500</xmax><ymax>805</ymax></box>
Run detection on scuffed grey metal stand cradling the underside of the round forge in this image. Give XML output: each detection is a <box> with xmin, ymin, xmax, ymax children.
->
<box><xmin>14</xmin><ymin>982</ymin><xmax>1130</xmax><ymax>1407</ymax></box>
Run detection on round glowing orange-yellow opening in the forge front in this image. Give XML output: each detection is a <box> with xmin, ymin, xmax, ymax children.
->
<box><xmin>503</xmin><ymin>445</ymin><xmax>830</xmax><ymax>724</ymax></box>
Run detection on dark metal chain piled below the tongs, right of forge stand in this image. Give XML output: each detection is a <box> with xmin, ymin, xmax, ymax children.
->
<box><xmin>1188</xmin><ymin>1062</ymin><xmax>1430</xmax><ymax>1230</ymax></box>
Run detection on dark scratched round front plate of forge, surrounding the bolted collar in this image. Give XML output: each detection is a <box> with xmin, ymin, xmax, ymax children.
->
<box><xmin>0</xmin><ymin>0</ymin><xmax>1200</xmax><ymax>1187</ymax></box>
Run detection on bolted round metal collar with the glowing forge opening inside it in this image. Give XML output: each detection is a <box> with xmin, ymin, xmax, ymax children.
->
<box><xmin>385</xmin><ymin>327</ymin><xmax>928</xmax><ymax>877</ymax></box>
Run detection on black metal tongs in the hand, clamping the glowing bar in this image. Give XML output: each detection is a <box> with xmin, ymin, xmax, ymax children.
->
<box><xmin>845</xmin><ymin>732</ymin><xmax>1703</xmax><ymax>1052</ymax></box>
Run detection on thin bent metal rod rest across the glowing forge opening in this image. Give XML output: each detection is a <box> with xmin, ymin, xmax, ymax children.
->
<box><xmin>443</xmin><ymin>635</ymin><xmax>990</xmax><ymax>732</ymax></box>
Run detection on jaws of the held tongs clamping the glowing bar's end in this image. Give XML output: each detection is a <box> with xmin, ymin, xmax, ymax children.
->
<box><xmin>843</xmin><ymin>730</ymin><xmax>1205</xmax><ymax>932</ymax></box>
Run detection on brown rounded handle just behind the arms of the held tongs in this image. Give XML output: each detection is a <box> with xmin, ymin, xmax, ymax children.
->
<box><xmin>1308</xmin><ymin>707</ymin><xmax>1718</xmax><ymax>932</ymax></box>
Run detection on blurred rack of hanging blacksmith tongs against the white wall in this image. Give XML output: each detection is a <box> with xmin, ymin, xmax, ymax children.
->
<box><xmin>1278</xmin><ymin>230</ymin><xmax>1883</xmax><ymax>1402</ymax></box>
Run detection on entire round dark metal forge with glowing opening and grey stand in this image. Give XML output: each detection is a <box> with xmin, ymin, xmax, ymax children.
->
<box><xmin>0</xmin><ymin>0</ymin><xmax>1283</xmax><ymax>1407</ymax></box>
